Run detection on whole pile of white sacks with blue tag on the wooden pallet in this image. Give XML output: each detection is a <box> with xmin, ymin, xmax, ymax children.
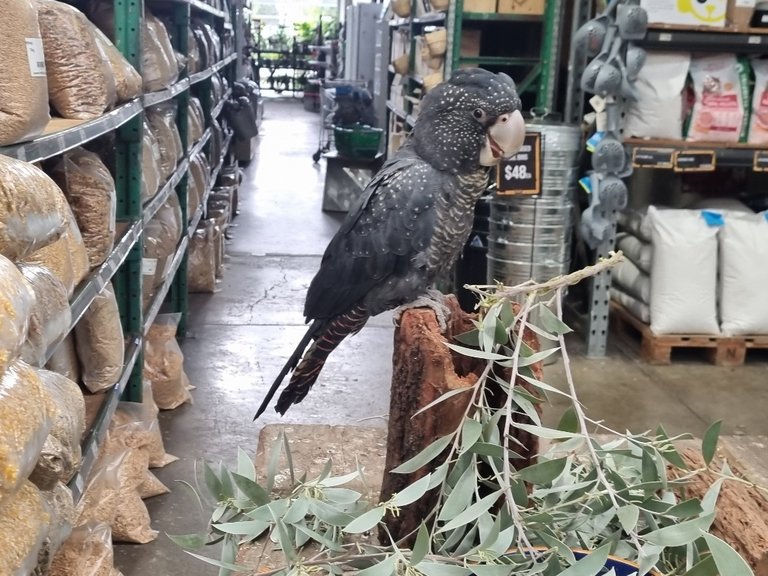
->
<box><xmin>611</xmin><ymin>201</ymin><xmax>768</xmax><ymax>336</ymax></box>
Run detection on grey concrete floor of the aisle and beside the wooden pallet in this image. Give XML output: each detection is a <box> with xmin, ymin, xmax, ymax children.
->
<box><xmin>116</xmin><ymin>100</ymin><xmax>768</xmax><ymax>576</ymax></box>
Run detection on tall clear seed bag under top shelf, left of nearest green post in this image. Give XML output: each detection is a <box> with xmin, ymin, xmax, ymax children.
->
<box><xmin>52</xmin><ymin>148</ymin><xmax>117</xmax><ymax>268</ymax></box>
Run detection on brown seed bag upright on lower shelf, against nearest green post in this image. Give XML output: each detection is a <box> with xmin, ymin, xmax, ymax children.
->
<box><xmin>75</xmin><ymin>283</ymin><xmax>125</xmax><ymax>392</ymax></box>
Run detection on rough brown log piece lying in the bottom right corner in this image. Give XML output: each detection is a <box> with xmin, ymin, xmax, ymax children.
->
<box><xmin>680</xmin><ymin>448</ymin><xmax>768</xmax><ymax>576</ymax></box>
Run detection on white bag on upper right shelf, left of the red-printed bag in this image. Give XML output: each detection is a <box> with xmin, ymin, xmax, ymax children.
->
<box><xmin>624</xmin><ymin>52</ymin><xmax>691</xmax><ymax>140</ymax></box>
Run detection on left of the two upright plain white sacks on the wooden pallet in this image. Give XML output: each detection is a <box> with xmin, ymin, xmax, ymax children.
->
<box><xmin>648</xmin><ymin>206</ymin><xmax>719</xmax><ymax>334</ymax></box>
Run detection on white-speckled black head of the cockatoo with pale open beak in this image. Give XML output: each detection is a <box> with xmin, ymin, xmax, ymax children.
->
<box><xmin>413</xmin><ymin>68</ymin><xmax>525</xmax><ymax>174</ymax></box>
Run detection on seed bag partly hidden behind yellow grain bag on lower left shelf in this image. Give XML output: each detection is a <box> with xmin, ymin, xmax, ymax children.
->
<box><xmin>29</xmin><ymin>370</ymin><xmax>85</xmax><ymax>490</ymax></box>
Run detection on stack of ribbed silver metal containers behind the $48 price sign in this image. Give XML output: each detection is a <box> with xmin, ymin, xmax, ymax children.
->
<box><xmin>488</xmin><ymin>119</ymin><xmax>581</xmax><ymax>286</ymax></box>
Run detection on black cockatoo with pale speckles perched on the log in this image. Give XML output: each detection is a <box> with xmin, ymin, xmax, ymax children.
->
<box><xmin>256</xmin><ymin>69</ymin><xmax>525</xmax><ymax>418</ymax></box>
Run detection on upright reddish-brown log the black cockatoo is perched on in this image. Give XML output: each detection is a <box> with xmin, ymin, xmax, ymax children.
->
<box><xmin>381</xmin><ymin>296</ymin><xmax>542</xmax><ymax>544</ymax></box>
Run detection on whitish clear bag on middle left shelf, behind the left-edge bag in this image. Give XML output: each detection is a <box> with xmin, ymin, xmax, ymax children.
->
<box><xmin>18</xmin><ymin>263</ymin><xmax>72</xmax><ymax>367</ymax></box>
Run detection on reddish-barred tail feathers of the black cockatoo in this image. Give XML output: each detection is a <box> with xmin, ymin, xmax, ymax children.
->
<box><xmin>275</xmin><ymin>306</ymin><xmax>369</xmax><ymax>414</ymax></box>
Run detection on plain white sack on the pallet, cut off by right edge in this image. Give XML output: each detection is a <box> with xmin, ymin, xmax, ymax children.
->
<box><xmin>720</xmin><ymin>212</ymin><xmax>768</xmax><ymax>336</ymax></box>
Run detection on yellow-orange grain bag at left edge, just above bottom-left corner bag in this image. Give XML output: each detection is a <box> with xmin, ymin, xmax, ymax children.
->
<box><xmin>0</xmin><ymin>360</ymin><xmax>55</xmax><ymax>501</ymax></box>
